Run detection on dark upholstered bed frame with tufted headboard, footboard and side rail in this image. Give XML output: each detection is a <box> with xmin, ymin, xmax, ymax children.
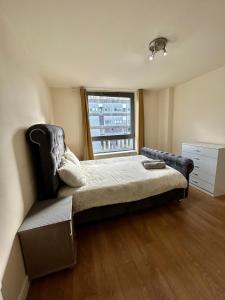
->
<box><xmin>26</xmin><ymin>124</ymin><xmax>193</xmax><ymax>224</ymax></box>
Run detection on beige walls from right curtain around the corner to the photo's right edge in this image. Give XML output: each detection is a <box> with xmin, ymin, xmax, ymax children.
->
<box><xmin>144</xmin><ymin>67</ymin><xmax>225</xmax><ymax>154</ymax></box>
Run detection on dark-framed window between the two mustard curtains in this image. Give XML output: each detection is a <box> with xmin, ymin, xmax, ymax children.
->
<box><xmin>88</xmin><ymin>92</ymin><xmax>135</xmax><ymax>154</ymax></box>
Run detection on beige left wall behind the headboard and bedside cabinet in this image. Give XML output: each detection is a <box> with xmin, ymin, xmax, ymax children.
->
<box><xmin>0</xmin><ymin>11</ymin><xmax>50</xmax><ymax>300</ymax></box>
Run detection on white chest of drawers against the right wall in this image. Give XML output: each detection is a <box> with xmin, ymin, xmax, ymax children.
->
<box><xmin>182</xmin><ymin>143</ymin><xmax>225</xmax><ymax>197</ymax></box>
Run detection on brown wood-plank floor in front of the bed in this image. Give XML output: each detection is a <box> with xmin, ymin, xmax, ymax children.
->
<box><xmin>28</xmin><ymin>189</ymin><xmax>225</xmax><ymax>300</ymax></box>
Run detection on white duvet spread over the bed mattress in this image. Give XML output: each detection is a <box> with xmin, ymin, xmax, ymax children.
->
<box><xmin>58</xmin><ymin>155</ymin><xmax>187</xmax><ymax>212</ymax></box>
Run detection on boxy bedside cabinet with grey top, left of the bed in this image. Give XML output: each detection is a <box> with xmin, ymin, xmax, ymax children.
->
<box><xmin>18</xmin><ymin>196</ymin><xmax>76</xmax><ymax>279</ymax></box>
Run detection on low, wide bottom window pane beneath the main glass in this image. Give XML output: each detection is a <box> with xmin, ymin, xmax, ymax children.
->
<box><xmin>92</xmin><ymin>138</ymin><xmax>134</xmax><ymax>153</ymax></box>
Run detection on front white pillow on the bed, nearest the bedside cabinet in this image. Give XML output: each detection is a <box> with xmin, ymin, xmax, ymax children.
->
<box><xmin>57</xmin><ymin>158</ymin><xmax>86</xmax><ymax>187</ymax></box>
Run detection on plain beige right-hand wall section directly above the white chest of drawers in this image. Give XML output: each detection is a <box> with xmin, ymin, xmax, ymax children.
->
<box><xmin>172</xmin><ymin>67</ymin><xmax>225</xmax><ymax>153</ymax></box>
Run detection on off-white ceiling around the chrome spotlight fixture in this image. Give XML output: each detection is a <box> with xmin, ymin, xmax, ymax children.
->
<box><xmin>0</xmin><ymin>0</ymin><xmax>225</xmax><ymax>89</ymax></box>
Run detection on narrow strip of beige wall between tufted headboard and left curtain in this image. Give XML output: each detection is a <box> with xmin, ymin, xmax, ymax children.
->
<box><xmin>51</xmin><ymin>88</ymin><xmax>83</xmax><ymax>159</ymax></box>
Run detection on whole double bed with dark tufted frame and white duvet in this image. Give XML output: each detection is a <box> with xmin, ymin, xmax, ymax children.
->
<box><xmin>26</xmin><ymin>124</ymin><xmax>193</xmax><ymax>224</ymax></box>
